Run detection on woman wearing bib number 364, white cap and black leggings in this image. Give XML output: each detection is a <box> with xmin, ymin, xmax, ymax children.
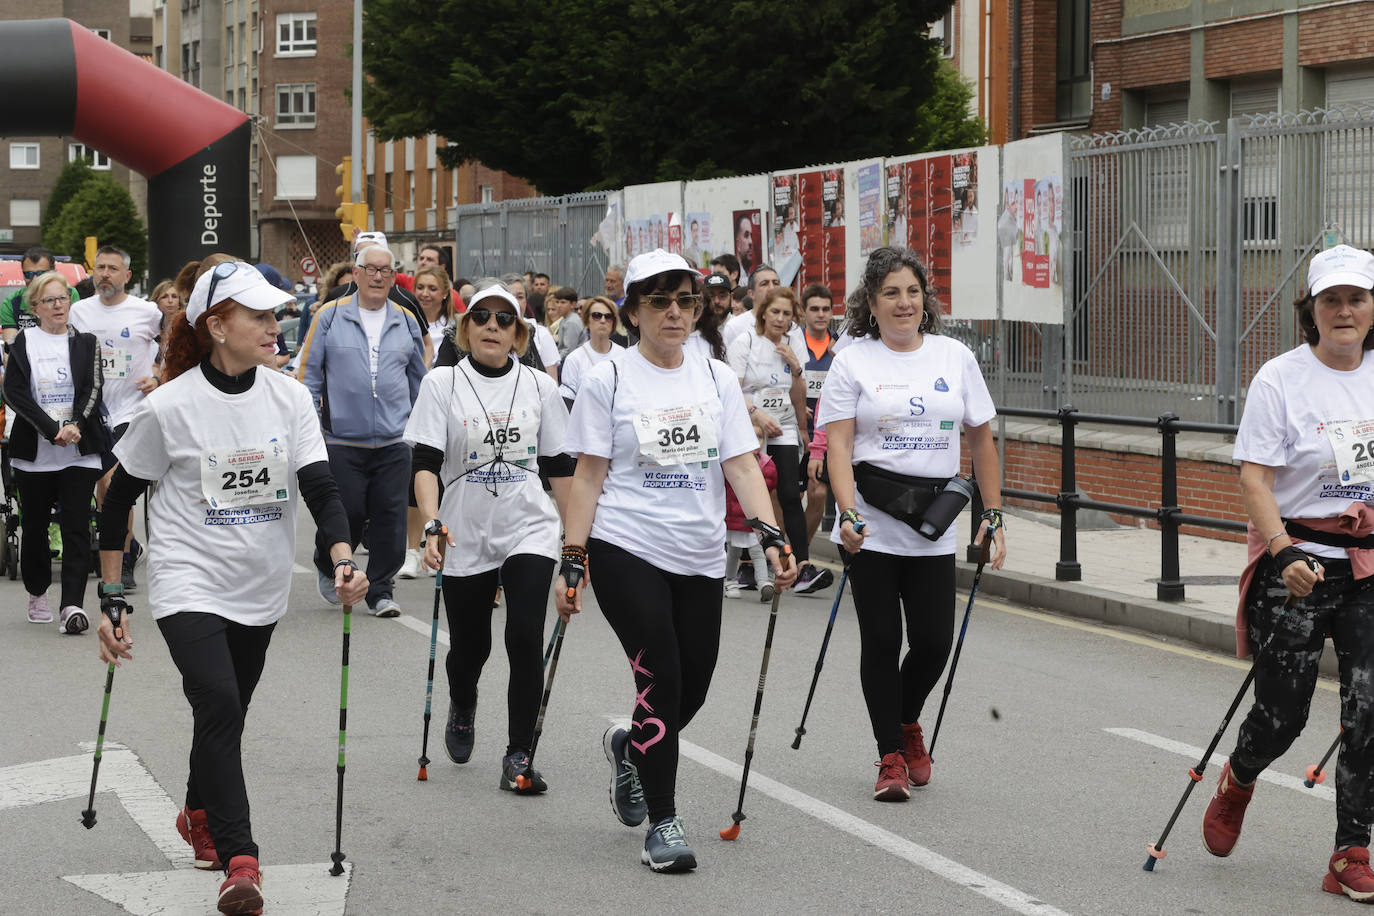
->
<box><xmin>556</xmin><ymin>250</ymin><xmax>797</xmax><ymax>872</ymax></box>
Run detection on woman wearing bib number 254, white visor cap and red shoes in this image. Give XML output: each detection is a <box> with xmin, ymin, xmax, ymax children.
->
<box><xmin>99</xmin><ymin>261</ymin><xmax>367</xmax><ymax>913</ymax></box>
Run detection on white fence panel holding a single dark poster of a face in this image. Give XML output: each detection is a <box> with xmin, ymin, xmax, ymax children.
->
<box><xmin>683</xmin><ymin>174</ymin><xmax>769</xmax><ymax>283</ymax></box>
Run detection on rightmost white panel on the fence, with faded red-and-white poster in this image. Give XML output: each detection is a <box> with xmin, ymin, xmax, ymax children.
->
<box><xmin>996</xmin><ymin>135</ymin><xmax>1065</xmax><ymax>324</ymax></box>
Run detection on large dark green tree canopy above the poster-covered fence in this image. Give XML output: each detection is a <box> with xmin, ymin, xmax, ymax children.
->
<box><xmin>363</xmin><ymin>0</ymin><xmax>982</xmax><ymax>194</ymax></box>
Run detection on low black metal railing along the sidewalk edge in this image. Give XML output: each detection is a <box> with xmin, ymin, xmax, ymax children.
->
<box><xmin>967</xmin><ymin>405</ymin><xmax>1246</xmax><ymax>602</ymax></box>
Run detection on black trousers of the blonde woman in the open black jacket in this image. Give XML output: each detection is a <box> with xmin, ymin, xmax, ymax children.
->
<box><xmin>14</xmin><ymin>467</ymin><xmax>100</xmax><ymax>607</ymax></box>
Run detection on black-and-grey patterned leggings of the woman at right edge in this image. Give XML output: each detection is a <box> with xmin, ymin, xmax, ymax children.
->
<box><xmin>1231</xmin><ymin>558</ymin><xmax>1374</xmax><ymax>846</ymax></box>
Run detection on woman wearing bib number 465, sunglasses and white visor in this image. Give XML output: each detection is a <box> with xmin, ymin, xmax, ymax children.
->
<box><xmin>405</xmin><ymin>282</ymin><xmax>576</xmax><ymax>794</ymax></box>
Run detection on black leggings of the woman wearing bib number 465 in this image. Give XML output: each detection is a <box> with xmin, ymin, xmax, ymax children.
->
<box><xmin>444</xmin><ymin>553</ymin><xmax>554</xmax><ymax>754</ymax></box>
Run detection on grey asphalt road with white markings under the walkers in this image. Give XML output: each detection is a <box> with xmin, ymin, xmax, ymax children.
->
<box><xmin>0</xmin><ymin>519</ymin><xmax>1355</xmax><ymax>916</ymax></box>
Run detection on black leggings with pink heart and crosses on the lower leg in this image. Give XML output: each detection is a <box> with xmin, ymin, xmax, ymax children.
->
<box><xmin>587</xmin><ymin>538</ymin><xmax>723</xmax><ymax>824</ymax></box>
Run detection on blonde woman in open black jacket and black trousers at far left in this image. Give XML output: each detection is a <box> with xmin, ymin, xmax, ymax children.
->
<box><xmin>4</xmin><ymin>272</ymin><xmax>104</xmax><ymax>634</ymax></box>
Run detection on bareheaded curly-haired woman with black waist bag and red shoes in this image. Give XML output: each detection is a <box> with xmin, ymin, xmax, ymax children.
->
<box><xmin>816</xmin><ymin>247</ymin><xmax>1006</xmax><ymax>801</ymax></box>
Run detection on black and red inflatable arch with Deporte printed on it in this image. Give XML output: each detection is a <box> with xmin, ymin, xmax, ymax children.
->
<box><xmin>0</xmin><ymin>19</ymin><xmax>251</xmax><ymax>279</ymax></box>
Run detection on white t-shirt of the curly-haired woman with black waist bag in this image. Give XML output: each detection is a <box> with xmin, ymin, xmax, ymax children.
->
<box><xmin>816</xmin><ymin>334</ymin><xmax>998</xmax><ymax>556</ymax></box>
